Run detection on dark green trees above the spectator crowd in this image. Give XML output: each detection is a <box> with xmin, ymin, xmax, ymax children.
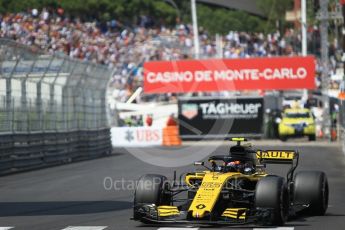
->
<box><xmin>0</xmin><ymin>0</ymin><xmax>276</xmax><ymax>34</ymax></box>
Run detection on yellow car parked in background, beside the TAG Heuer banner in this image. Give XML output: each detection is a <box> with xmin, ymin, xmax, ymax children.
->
<box><xmin>278</xmin><ymin>108</ymin><xmax>316</xmax><ymax>141</ymax></box>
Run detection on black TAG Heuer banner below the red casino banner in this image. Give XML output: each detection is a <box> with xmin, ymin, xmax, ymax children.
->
<box><xmin>178</xmin><ymin>97</ymin><xmax>264</xmax><ymax>138</ymax></box>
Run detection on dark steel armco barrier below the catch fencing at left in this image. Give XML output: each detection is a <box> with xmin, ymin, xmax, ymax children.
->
<box><xmin>0</xmin><ymin>129</ymin><xmax>111</xmax><ymax>175</ymax></box>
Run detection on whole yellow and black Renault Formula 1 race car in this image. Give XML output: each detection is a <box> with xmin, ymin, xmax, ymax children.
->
<box><xmin>132</xmin><ymin>138</ymin><xmax>328</xmax><ymax>225</ymax></box>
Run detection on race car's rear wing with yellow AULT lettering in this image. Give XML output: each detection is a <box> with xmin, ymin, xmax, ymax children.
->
<box><xmin>256</xmin><ymin>150</ymin><xmax>299</xmax><ymax>182</ymax></box>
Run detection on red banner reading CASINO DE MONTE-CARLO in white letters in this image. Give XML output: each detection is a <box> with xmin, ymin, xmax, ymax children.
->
<box><xmin>144</xmin><ymin>56</ymin><xmax>315</xmax><ymax>93</ymax></box>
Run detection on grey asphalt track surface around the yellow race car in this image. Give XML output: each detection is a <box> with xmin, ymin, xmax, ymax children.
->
<box><xmin>0</xmin><ymin>142</ymin><xmax>345</xmax><ymax>230</ymax></box>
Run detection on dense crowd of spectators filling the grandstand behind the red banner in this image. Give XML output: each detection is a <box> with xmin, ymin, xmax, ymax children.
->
<box><xmin>0</xmin><ymin>9</ymin><xmax>336</xmax><ymax>101</ymax></box>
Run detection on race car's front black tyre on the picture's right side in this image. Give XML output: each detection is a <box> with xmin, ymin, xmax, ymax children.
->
<box><xmin>255</xmin><ymin>176</ymin><xmax>289</xmax><ymax>225</ymax></box>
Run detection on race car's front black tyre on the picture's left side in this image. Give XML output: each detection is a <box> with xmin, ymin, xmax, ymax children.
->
<box><xmin>134</xmin><ymin>174</ymin><xmax>171</xmax><ymax>219</ymax></box>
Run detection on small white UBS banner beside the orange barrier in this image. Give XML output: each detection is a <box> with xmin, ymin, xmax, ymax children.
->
<box><xmin>111</xmin><ymin>127</ymin><xmax>163</xmax><ymax>147</ymax></box>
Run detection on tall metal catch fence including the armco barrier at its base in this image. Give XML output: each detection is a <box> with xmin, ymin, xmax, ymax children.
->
<box><xmin>0</xmin><ymin>39</ymin><xmax>111</xmax><ymax>174</ymax></box>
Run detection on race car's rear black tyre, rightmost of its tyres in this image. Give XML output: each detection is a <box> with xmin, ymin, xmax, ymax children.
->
<box><xmin>294</xmin><ymin>171</ymin><xmax>329</xmax><ymax>216</ymax></box>
